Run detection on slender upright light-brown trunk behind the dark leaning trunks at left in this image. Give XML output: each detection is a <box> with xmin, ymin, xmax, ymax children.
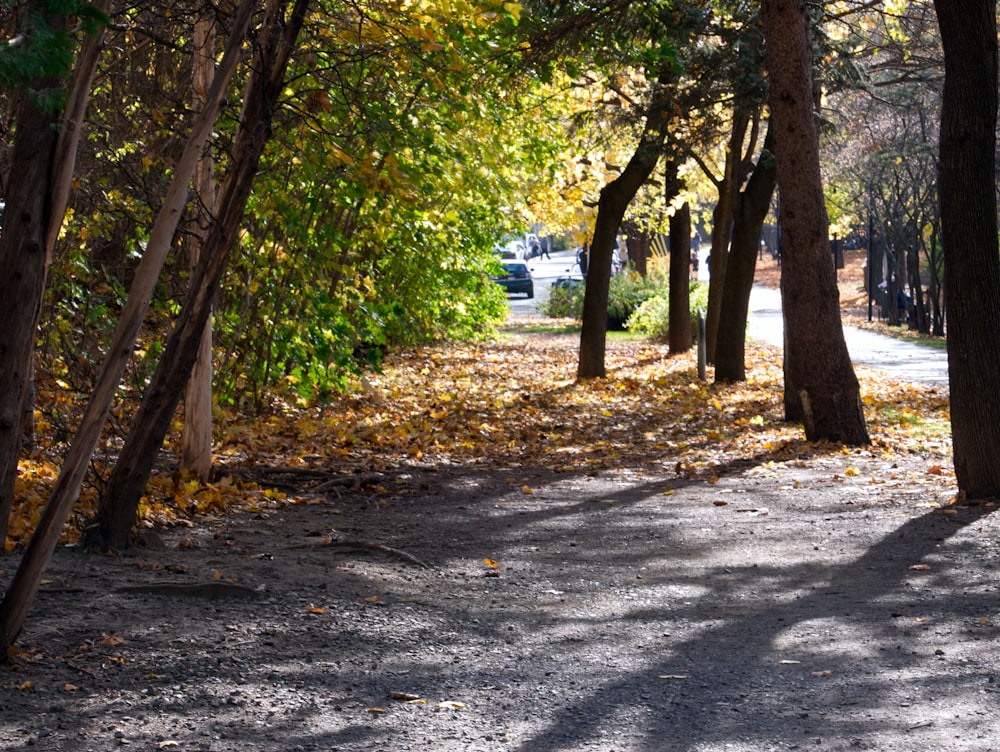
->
<box><xmin>181</xmin><ymin>14</ymin><xmax>222</xmax><ymax>483</ymax></box>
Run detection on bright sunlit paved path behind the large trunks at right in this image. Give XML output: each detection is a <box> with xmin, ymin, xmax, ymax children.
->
<box><xmin>747</xmin><ymin>287</ymin><xmax>948</xmax><ymax>385</ymax></box>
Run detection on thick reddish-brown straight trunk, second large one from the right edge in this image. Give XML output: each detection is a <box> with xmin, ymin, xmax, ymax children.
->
<box><xmin>763</xmin><ymin>0</ymin><xmax>868</xmax><ymax>445</ymax></box>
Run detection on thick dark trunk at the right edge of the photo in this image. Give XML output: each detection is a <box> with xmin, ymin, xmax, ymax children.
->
<box><xmin>934</xmin><ymin>0</ymin><xmax>1000</xmax><ymax>499</ymax></box>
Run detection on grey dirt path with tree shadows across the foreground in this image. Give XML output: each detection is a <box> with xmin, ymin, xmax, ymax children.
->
<box><xmin>0</xmin><ymin>449</ymin><xmax>1000</xmax><ymax>752</ymax></box>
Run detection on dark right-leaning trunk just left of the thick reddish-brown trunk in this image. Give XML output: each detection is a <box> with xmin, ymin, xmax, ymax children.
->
<box><xmin>715</xmin><ymin>129</ymin><xmax>777</xmax><ymax>381</ymax></box>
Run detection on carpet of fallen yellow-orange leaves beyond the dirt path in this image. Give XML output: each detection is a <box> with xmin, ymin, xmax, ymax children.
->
<box><xmin>6</xmin><ymin>331</ymin><xmax>954</xmax><ymax>550</ymax></box>
